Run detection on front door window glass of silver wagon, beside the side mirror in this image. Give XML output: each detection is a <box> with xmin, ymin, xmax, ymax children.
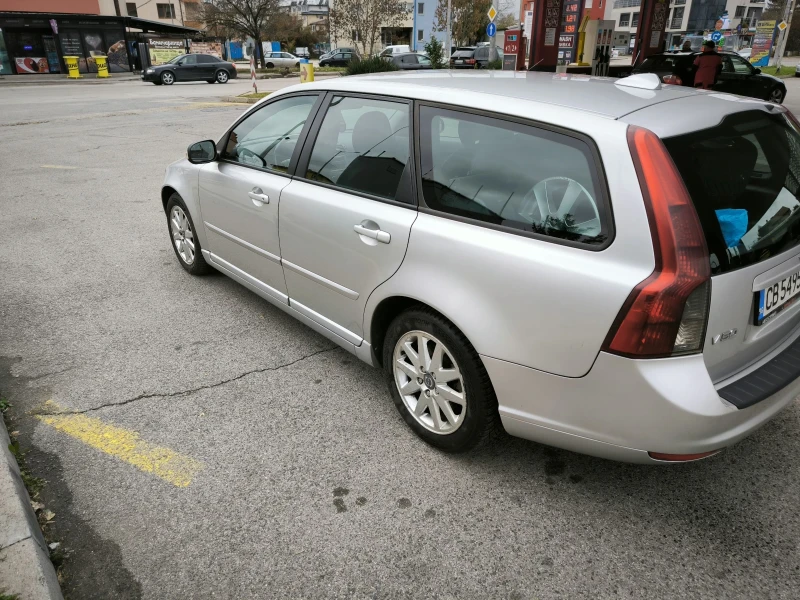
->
<box><xmin>222</xmin><ymin>96</ymin><xmax>317</xmax><ymax>173</ymax></box>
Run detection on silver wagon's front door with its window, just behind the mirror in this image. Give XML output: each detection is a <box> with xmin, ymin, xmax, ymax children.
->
<box><xmin>199</xmin><ymin>94</ymin><xmax>319</xmax><ymax>303</ymax></box>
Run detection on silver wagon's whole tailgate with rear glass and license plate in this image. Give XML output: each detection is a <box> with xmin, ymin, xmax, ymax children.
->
<box><xmin>664</xmin><ymin>107</ymin><xmax>800</xmax><ymax>382</ymax></box>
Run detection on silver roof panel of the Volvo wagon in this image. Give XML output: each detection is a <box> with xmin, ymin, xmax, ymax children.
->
<box><xmin>292</xmin><ymin>70</ymin><xmax>705</xmax><ymax>119</ymax></box>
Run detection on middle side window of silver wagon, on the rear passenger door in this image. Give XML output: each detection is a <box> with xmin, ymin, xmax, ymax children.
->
<box><xmin>306</xmin><ymin>96</ymin><xmax>409</xmax><ymax>200</ymax></box>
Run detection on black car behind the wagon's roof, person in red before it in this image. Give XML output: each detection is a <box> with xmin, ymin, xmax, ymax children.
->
<box><xmin>633</xmin><ymin>52</ymin><xmax>786</xmax><ymax>104</ymax></box>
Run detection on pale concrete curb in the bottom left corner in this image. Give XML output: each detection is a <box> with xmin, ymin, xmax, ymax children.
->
<box><xmin>0</xmin><ymin>419</ymin><xmax>64</xmax><ymax>600</ymax></box>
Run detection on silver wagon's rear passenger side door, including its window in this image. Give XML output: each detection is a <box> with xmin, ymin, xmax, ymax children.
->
<box><xmin>280</xmin><ymin>94</ymin><xmax>417</xmax><ymax>345</ymax></box>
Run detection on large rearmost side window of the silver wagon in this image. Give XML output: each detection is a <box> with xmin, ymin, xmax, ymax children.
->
<box><xmin>420</xmin><ymin>106</ymin><xmax>608</xmax><ymax>245</ymax></box>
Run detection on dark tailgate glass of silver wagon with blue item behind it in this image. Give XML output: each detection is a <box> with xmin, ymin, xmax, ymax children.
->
<box><xmin>664</xmin><ymin>111</ymin><xmax>800</xmax><ymax>274</ymax></box>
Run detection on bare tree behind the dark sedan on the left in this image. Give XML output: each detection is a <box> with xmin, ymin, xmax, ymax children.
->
<box><xmin>203</xmin><ymin>0</ymin><xmax>281</xmax><ymax>67</ymax></box>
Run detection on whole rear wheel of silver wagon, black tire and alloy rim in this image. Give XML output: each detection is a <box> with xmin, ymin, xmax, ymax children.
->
<box><xmin>383</xmin><ymin>306</ymin><xmax>499</xmax><ymax>453</ymax></box>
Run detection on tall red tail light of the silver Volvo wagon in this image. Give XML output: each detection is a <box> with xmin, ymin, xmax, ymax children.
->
<box><xmin>603</xmin><ymin>126</ymin><xmax>711</xmax><ymax>358</ymax></box>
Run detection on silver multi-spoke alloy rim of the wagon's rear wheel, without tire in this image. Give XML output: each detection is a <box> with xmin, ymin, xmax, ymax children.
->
<box><xmin>393</xmin><ymin>331</ymin><xmax>467</xmax><ymax>435</ymax></box>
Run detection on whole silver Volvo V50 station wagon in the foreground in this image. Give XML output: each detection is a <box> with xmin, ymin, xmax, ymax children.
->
<box><xmin>162</xmin><ymin>72</ymin><xmax>800</xmax><ymax>463</ymax></box>
